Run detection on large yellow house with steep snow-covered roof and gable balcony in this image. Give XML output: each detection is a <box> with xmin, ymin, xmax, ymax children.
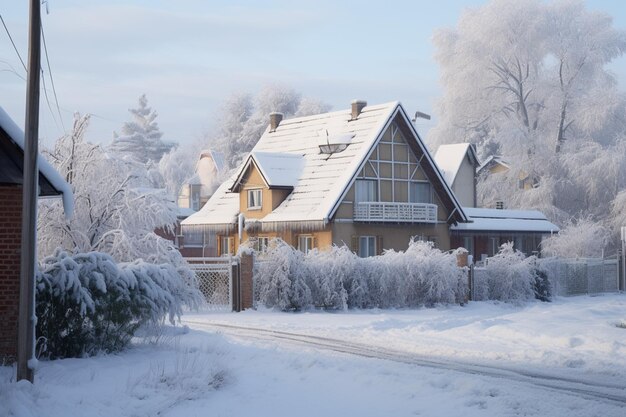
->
<box><xmin>181</xmin><ymin>101</ymin><xmax>468</xmax><ymax>256</ymax></box>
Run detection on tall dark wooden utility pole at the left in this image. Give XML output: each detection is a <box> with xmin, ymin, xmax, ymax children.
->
<box><xmin>17</xmin><ymin>0</ymin><xmax>41</xmax><ymax>382</ymax></box>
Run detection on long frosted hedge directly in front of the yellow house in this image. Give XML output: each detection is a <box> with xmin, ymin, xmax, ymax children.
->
<box><xmin>255</xmin><ymin>240</ymin><xmax>467</xmax><ymax>310</ymax></box>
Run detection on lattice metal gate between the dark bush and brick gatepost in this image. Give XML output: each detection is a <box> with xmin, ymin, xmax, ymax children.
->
<box><xmin>186</xmin><ymin>256</ymin><xmax>238</xmax><ymax>311</ymax></box>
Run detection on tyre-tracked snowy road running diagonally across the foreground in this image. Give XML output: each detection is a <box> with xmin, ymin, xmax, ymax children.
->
<box><xmin>185</xmin><ymin>320</ymin><xmax>626</xmax><ymax>407</ymax></box>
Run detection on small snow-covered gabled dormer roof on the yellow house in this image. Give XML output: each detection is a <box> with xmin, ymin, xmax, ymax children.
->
<box><xmin>231</xmin><ymin>151</ymin><xmax>304</xmax><ymax>190</ymax></box>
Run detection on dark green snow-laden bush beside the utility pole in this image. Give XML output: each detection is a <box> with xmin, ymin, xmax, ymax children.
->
<box><xmin>36</xmin><ymin>250</ymin><xmax>199</xmax><ymax>359</ymax></box>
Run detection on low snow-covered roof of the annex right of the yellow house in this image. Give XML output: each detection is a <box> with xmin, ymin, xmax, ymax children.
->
<box><xmin>450</xmin><ymin>207</ymin><xmax>559</xmax><ymax>233</ymax></box>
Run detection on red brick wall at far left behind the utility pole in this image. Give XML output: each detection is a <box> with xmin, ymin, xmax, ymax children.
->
<box><xmin>0</xmin><ymin>186</ymin><xmax>22</xmax><ymax>365</ymax></box>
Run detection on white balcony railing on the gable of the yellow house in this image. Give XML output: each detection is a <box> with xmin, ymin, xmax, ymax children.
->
<box><xmin>354</xmin><ymin>201</ymin><xmax>437</xmax><ymax>223</ymax></box>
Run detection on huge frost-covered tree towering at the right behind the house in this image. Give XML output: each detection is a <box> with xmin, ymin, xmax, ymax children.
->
<box><xmin>428</xmin><ymin>0</ymin><xmax>626</xmax><ymax>247</ymax></box>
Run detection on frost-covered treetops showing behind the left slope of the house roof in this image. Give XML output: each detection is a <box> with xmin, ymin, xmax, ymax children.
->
<box><xmin>207</xmin><ymin>85</ymin><xmax>330</xmax><ymax>168</ymax></box>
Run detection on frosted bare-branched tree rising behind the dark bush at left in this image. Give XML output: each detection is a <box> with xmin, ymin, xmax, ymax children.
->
<box><xmin>38</xmin><ymin>114</ymin><xmax>184</xmax><ymax>265</ymax></box>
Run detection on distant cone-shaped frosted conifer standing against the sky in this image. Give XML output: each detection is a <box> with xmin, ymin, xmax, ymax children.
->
<box><xmin>109</xmin><ymin>94</ymin><xmax>174</xmax><ymax>164</ymax></box>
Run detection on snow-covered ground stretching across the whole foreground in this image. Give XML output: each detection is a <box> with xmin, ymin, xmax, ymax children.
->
<box><xmin>0</xmin><ymin>295</ymin><xmax>626</xmax><ymax>416</ymax></box>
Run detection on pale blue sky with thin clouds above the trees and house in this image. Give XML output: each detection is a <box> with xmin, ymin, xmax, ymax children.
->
<box><xmin>0</xmin><ymin>0</ymin><xmax>626</xmax><ymax>143</ymax></box>
